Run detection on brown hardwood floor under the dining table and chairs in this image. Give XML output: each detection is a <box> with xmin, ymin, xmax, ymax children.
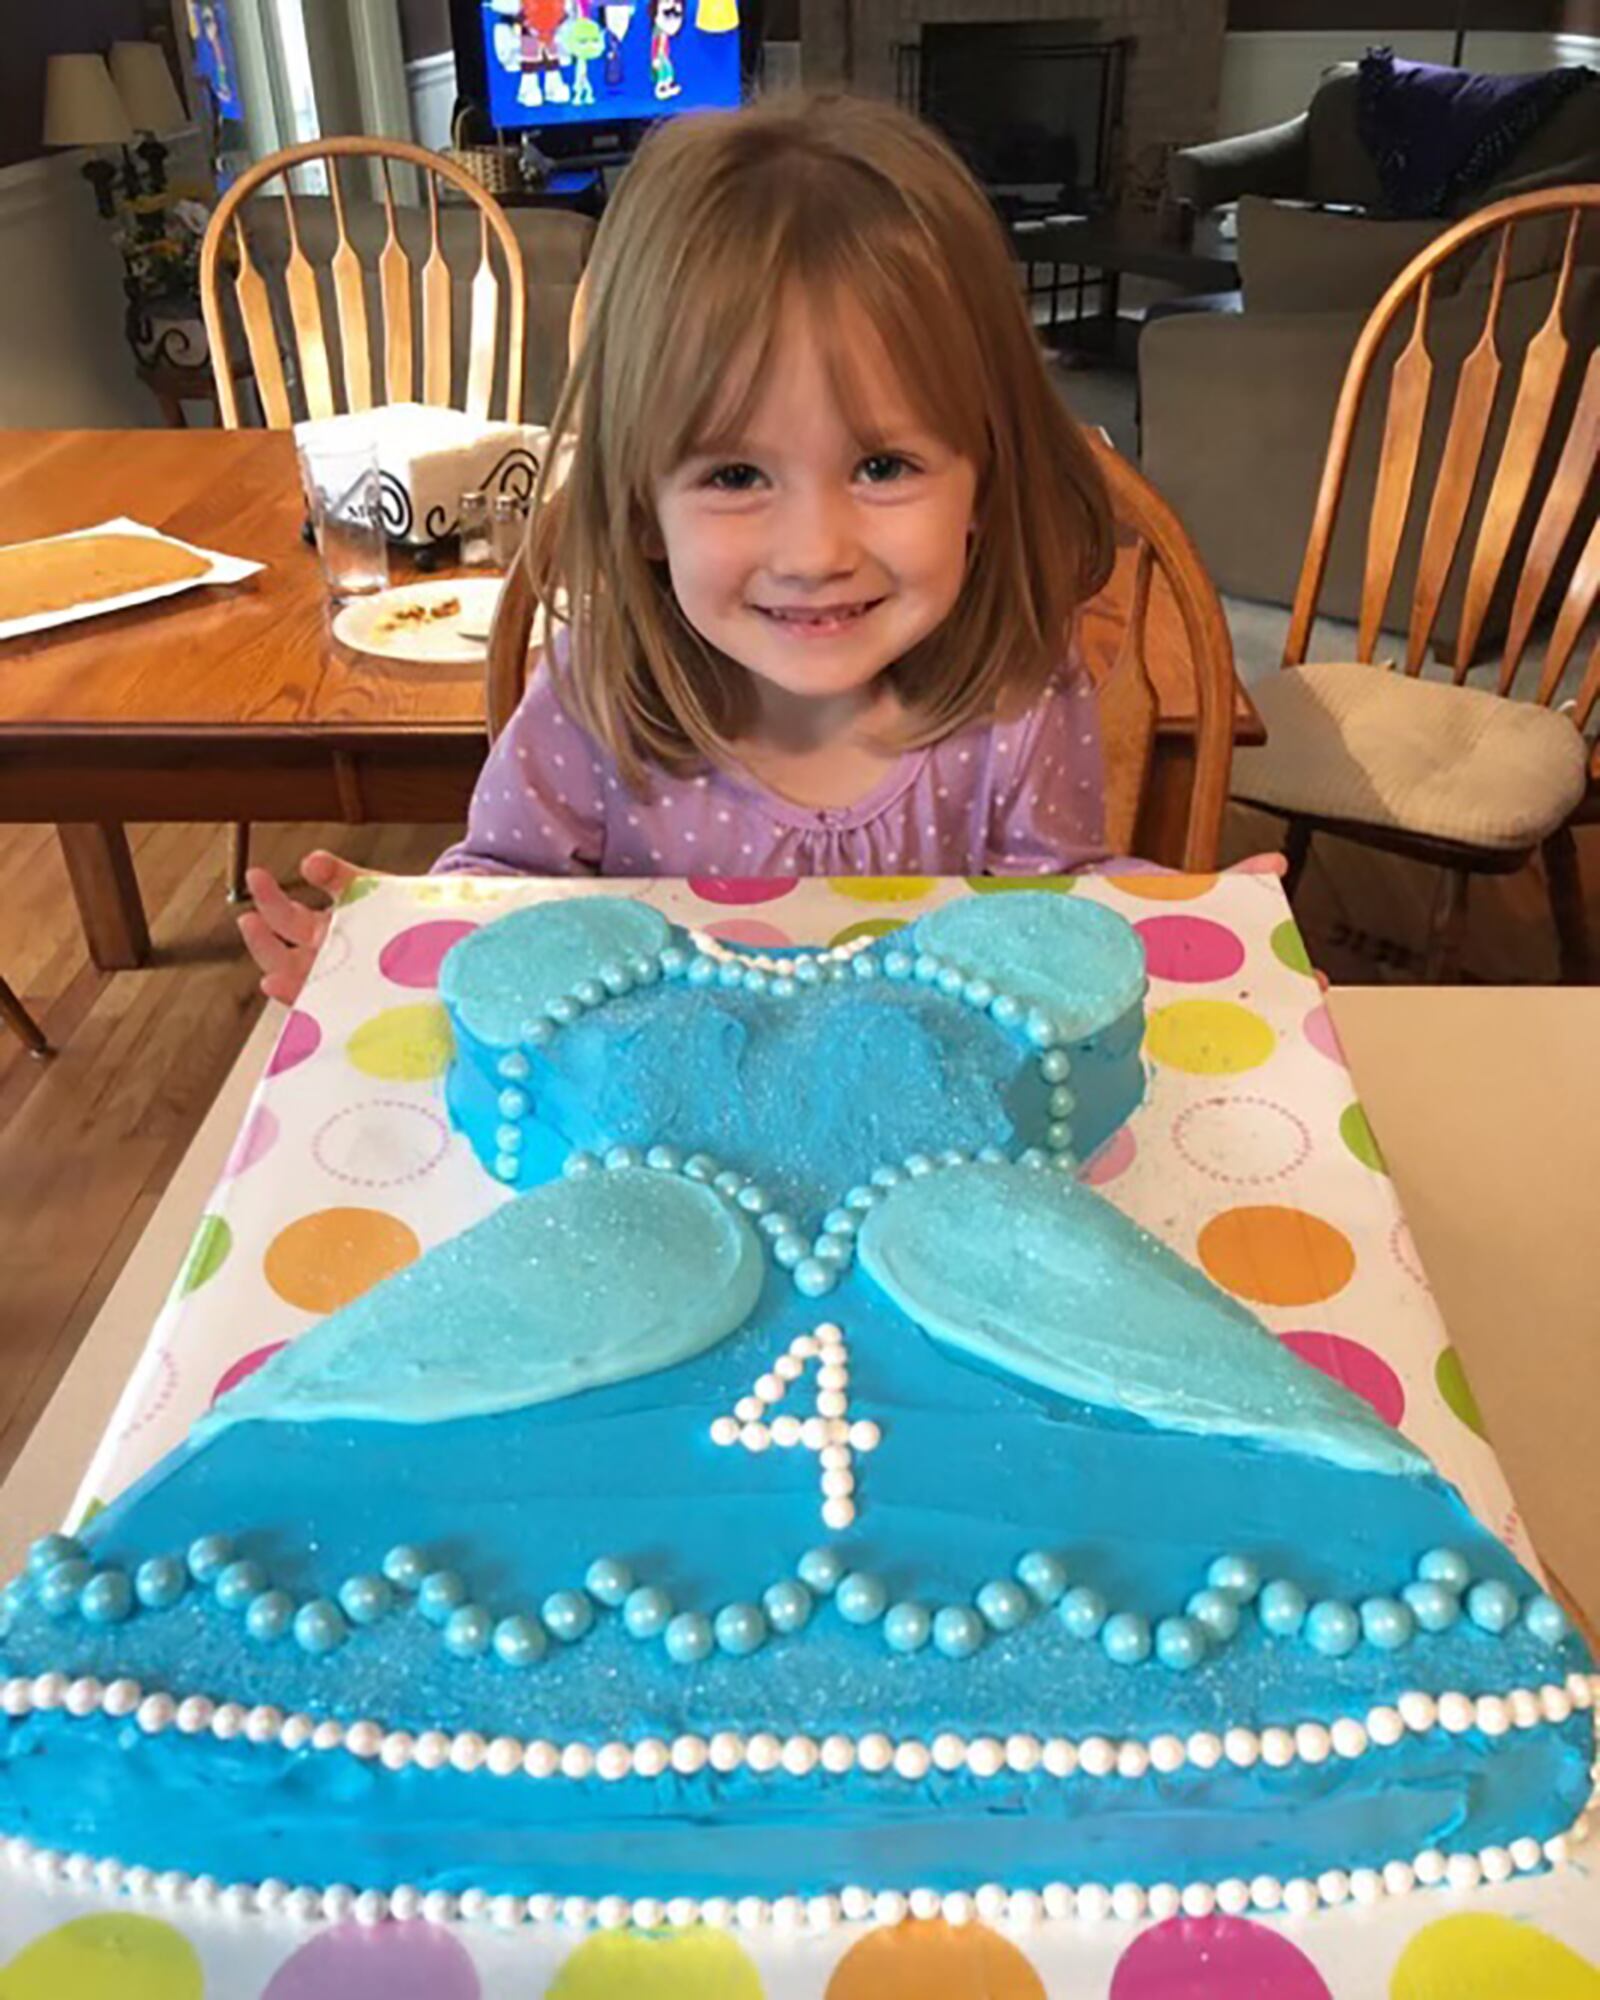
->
<box><xmin>0</xmin><ymin>812</ymin><xmax>1600</xmax><ymax>1478</ymax></box>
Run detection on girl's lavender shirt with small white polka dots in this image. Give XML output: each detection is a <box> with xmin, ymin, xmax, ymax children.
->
<box><xmin>434</xmin><ymin>664</ymin><xmax>1106</xmax><ymax>876</ymax></box>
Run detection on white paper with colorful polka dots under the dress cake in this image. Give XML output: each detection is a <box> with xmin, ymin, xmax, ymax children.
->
<box><xmin>0</xmin><ymin>868</ymin><xmax>1600</xmax><ymax>2000</ymax></box>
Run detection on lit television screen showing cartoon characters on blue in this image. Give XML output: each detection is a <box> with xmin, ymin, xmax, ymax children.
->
<box><xmin>478</xmin><ymin>0</ymin><xmax>750</xmax><ymax>130</ymax></box>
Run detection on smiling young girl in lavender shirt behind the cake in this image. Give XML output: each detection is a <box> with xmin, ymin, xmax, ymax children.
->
<box><xmin>240</xmin><ymin>96</ymin><xmax>1112</xmax><ymax>1000</ymax></box>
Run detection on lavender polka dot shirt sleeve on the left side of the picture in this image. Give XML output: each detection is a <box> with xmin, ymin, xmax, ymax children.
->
<box><xmin>432</xmin><ymin>662</ymin><xmax>610</xmax><ymax>876</ymax></box>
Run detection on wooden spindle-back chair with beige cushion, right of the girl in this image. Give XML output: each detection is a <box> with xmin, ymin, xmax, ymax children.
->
<box><xmin>1236</xmin><ymin>184</ymin><xmax>1600</xmax><ymax>978</ymax></box>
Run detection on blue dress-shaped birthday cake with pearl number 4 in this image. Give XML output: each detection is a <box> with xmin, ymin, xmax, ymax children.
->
<box><xmin>0</xmin><ymin>892</ymin><xmax>1596</xmax><ymax>1926</ymax></box>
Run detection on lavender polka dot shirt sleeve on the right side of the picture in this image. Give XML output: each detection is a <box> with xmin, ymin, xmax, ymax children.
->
<box><xmin>986</xmin><ymin>656</ymin><xmax>1106</xmax><ymax>874</ymax></box>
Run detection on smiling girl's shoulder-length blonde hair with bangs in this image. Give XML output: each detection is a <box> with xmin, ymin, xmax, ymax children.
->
<box><xmin>524</xmin><ymin>96</ymin><xmax>1114</xmax><ymax>786</ymax></box>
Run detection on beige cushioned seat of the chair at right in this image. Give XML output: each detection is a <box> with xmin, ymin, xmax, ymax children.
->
<box><xmin>1232</xmin><ymin>664</ymin><xmax>1588</xmax><ymax>850</ymax></box>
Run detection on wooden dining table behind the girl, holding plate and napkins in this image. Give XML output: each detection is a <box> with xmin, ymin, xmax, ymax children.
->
<box><xmin>0</xmin><ymin>430</ymin><xmax>1266</xmax><ymax>970</ymax></box>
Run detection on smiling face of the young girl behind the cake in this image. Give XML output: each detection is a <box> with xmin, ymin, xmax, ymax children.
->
<box><xmin>656</xmin><ymin>312</ymin><xmax>978</xmax><ymax>720</ymax></box>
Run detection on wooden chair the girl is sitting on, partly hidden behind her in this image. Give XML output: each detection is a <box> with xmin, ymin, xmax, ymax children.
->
<box><xmin>486</xmin><ymin>438</ymin><xmax>1236</xmax><ymax>870</ymax></box>
